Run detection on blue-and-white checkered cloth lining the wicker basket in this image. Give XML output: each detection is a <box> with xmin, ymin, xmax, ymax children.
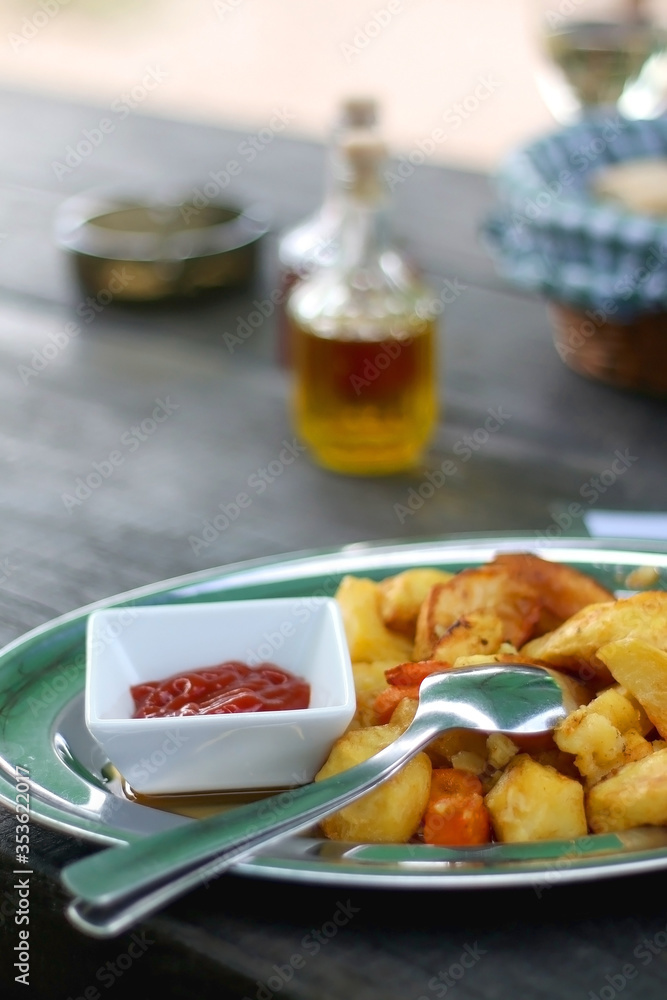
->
<box><xmin>483</xmin><ymin>111</ymin><xmax>667</xmax><ymax>323</ymax></box>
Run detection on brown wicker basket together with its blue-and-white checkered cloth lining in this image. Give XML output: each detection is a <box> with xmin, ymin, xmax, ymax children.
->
<box><xmin>483</xmin><ymin>111</ymin><xmax>667</xmax><ymax>397</ymax></box>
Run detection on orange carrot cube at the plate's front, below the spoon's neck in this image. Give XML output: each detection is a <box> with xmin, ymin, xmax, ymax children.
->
<box><xmin>423</xmin><ymin>767</ymin><xmax>491</xmax><ymax>847</ymax></box>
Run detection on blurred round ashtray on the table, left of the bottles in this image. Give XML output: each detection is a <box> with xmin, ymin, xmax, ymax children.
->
<box><xmin>56</xmin><ymin>194</ymin><xmax>269</xmax><ymax>302</ymax></box>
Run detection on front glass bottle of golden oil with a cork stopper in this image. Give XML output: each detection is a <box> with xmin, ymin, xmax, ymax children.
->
<box><xmin>287</xmin><ymin>130</ymin><xmax>438</xmax><ymax>475</ymax></box>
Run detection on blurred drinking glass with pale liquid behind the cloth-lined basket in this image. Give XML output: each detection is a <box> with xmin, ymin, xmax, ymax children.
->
<box><xmin>528</xmin><ymin>0</ymin><xmax>667</xmax><ymax>124</ymax></box>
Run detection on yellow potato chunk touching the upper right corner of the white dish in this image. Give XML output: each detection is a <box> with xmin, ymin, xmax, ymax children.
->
<box><xmin>336</xmin><ymin>576</ymin><xmax>412</xmax><ymax>664</ymax></box>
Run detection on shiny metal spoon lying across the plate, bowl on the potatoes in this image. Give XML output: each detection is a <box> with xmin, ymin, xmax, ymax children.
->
<box><xmin>62</xmin><ymin>663</ymin><xmax>566</xmax><ymax>938</ymax></box>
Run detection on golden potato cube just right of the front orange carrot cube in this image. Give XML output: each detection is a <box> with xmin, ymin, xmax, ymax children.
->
<box><xmin>484</xmin><ymin>754</ymin><xmax>588</xmax><ymax>842</ymax></box>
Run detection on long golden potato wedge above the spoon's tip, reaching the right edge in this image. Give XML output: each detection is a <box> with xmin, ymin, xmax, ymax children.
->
<box><xmin>521</xmin><ymin>590</ymin><xmax>667</xmax><ymax>687</ymax></box>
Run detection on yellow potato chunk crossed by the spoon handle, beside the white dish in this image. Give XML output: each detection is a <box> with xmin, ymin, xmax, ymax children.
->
<box><xmin>315</xmin><ymin>725</ymin><xmax>431</xmax><ymax>844</ymax></box>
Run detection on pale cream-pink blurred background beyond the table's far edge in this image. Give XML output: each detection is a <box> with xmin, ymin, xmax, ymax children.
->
<box><xmin>0</xmin><ymin>0</ymin><xmax>560</xmax><ymax>170</ymax></box>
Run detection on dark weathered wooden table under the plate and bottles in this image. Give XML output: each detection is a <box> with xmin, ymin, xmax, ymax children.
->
<box><xmin>0</xmin><ymin>93</ymin><xmax>667</xmax><ymax>1000</ymax></box>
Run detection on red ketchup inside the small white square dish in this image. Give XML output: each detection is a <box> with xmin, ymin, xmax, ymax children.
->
<box><xmin>130</xmin><ymin>660</ymin><xmax>310</xmax><ymax>719</ymax></box>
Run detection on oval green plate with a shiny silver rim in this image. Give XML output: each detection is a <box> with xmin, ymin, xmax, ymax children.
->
<box><xmin>0</xmin><ymin>535</ymin><xmax>667</xmax><ymax>889</ymax></box>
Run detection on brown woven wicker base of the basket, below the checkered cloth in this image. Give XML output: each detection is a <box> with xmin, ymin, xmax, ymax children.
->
<box><xmin>549</xmin><ymin>303</ymin><xmax>667</xmax><ymax>396</ymax></box>
